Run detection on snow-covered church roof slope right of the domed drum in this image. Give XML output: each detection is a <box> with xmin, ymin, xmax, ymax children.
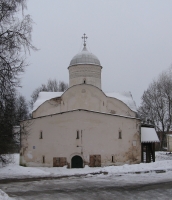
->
<box><xmin>105</xmin><ymin>92</ymin><xmax>137</xmax><ymax>112</ymax></box>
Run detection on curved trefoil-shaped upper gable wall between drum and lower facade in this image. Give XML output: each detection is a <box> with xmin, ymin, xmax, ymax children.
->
<box><xmin>32</xmin><ymin>84</ymin><xmax>136</xmax><ymax>118</ymax></box>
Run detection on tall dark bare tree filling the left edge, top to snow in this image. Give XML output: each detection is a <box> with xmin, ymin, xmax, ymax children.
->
<box><xmin>0</xmin><ymin>0</ymin><xmax>36</xmax><ymax>164</ymax></box>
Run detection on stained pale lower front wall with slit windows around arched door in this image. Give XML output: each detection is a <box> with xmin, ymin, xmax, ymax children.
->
<box><xmin>20</xmin><ymin>111</ymin><xmax>141</xmax><ymax>167</ymax></box>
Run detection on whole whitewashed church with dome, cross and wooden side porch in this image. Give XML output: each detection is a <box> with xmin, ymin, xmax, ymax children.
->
<box><xmin>20</xmin><ymin>34</ymin><xmax>159</xmax><ymax>168</ymax></box>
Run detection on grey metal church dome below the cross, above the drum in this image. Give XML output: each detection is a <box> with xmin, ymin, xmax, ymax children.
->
<box><xmin>69</xmin><ymin>46</ymin><xmax>101</xmax><ymax>67</ymax></box>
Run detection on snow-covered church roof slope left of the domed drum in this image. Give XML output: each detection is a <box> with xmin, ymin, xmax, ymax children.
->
<box><xmin>32</xmin><ymin>92</ymin><xmax>63</xmax><ymax>112</ymax></box>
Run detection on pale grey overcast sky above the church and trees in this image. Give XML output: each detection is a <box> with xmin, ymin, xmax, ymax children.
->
<box><xmin>17</xmin><ymin>0</ymin><xmax>172</xmax><ymax>106</ymax></box>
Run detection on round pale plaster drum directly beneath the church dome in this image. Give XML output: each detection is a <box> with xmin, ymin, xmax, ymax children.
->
<box><xmin>68</xmin><ymin>65</ymin><xmax>102</xmax><ymax>89</ymax></box>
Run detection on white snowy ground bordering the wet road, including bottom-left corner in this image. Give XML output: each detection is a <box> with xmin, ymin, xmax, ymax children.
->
<box><xmin>0</xmin><ymin>152</ymin><xmax>172</xmax><ymax>200</ymax></box>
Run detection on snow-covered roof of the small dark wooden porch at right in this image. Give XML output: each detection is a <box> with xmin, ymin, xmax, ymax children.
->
<box><xmin>141</xmin><ymin>127</ymin><xmax>159</xmax><ymax>143</ymax></box>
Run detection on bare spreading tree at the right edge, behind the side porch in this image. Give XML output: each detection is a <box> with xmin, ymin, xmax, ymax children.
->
<box><xmin>138</xmin><ymin>68</ymin><xmax>172</xmax><ymax>148</ymax></box>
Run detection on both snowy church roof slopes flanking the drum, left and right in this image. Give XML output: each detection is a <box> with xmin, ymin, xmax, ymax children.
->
<box><xmin>32</xmin><ymin>92</ymin><xmax>137</xmax><ymax>112</ymax></box>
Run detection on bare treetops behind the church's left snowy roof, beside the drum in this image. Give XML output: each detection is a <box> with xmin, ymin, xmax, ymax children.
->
<box><xmin>29</xmin><ymin>79</ymin><xmax>68</xmax><ymax>109</ymax></box>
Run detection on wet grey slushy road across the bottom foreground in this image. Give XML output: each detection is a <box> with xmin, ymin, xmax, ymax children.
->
<box><xmin>0</xmin><ymin>173</ymin><xmax>172</xmax><ymax>200</ymax></box>
